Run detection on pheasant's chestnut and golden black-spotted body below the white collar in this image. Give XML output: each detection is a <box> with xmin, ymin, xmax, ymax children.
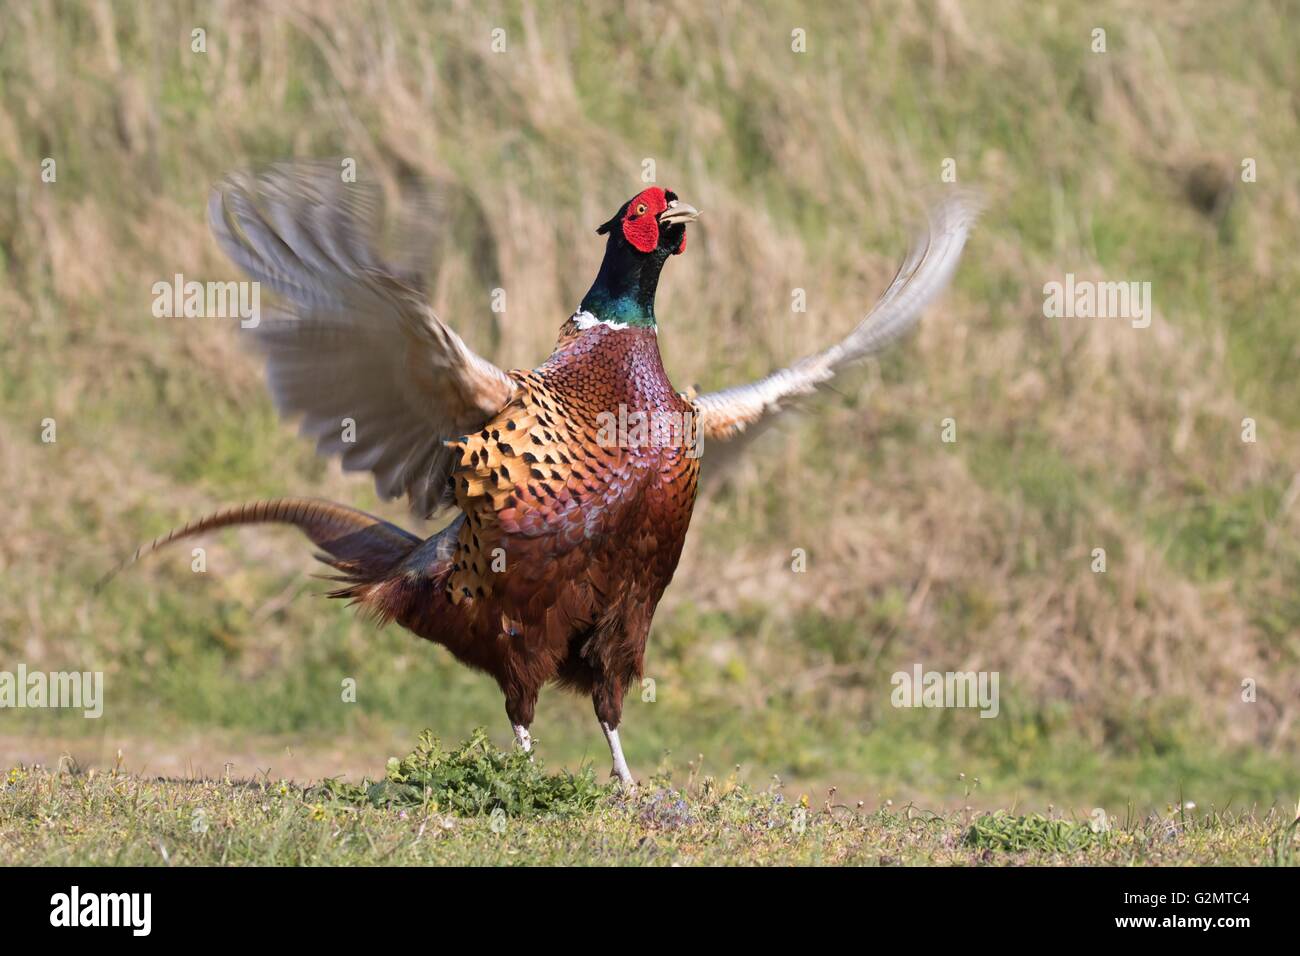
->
<box><xmin>397</xmin><ymin>324</ymin><xmax>699</xmax><ymax>724</ymax></box>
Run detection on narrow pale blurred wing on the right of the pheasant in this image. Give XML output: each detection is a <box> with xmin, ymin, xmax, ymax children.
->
<box><xmin>696</xmin><ymin>193</ymin><xmax>980</xmax><ymax>450</ymax></box>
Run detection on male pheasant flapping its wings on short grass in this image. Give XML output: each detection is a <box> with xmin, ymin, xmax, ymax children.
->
<box><xmin>111</xmin><ymin>164</ymin><xmax>976</xmax><ymax>788</ymax></box>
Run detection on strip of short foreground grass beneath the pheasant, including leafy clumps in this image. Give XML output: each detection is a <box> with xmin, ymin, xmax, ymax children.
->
<box><xmin>0</xmin><ymin>734</ymin><xmax>1300</xmax><ymax>866</ymax></box>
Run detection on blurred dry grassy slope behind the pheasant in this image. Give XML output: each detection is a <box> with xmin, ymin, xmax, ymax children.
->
<box><xmin>0</xmin><ymin>0</ymin><xmax>1300</xmax><ymax>809</ymax></box>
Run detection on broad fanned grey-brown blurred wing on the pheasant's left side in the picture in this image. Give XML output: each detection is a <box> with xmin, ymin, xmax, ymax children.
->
<box><xmin>208</xmin><ymin>164</ymin><xmax>515</xmax><ymax>516</ymax></box>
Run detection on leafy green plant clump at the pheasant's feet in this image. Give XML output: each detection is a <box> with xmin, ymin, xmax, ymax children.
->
<box><xmin>307</xmin><ymin>727</ymin><xmax>612</xmax><ymax>817</ymax></box>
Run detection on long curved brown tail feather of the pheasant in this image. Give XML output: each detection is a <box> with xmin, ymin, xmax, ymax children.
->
<box><xmin>95</xmin><ymin>498</ymin><xmax>421</xmax><ymax>593</ymax></box>
